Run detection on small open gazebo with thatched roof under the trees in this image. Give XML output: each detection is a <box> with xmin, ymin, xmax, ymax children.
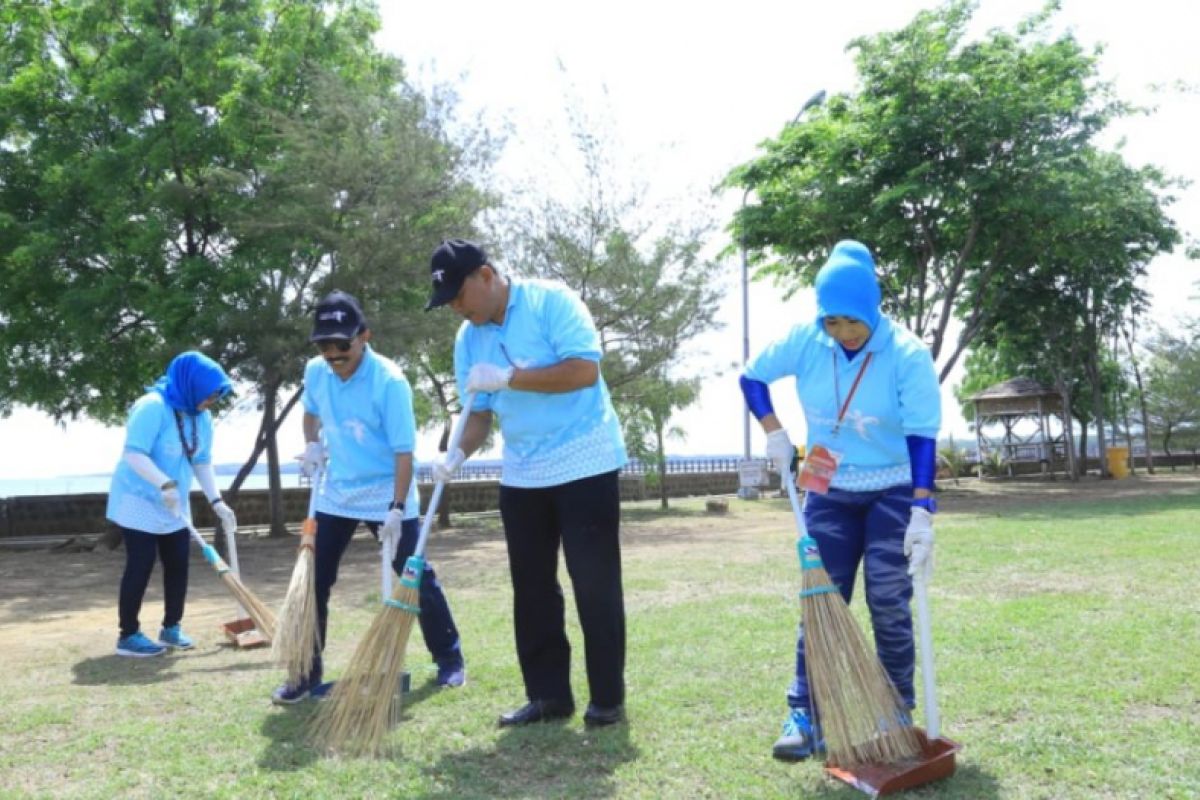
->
<box><xmin>971</xmin><ymin>378</ymin><xmax>1070</xmax><ymax>474</ymax></box>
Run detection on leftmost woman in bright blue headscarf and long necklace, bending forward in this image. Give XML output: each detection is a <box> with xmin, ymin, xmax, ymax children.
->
<box><xmin>106</xmin><ymin>351</ymin><xmax>238</xmax><ymax>657</ymax></box>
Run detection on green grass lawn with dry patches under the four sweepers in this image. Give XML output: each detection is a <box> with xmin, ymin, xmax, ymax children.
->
<box><xmin>0</xmin><ymin>479</ymin><xmax>1200</xmax><ymax>800</ymax></box>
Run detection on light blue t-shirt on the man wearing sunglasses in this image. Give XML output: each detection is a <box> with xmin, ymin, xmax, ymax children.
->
<box><xmin>302</xmin><ymin>345</ymin><xmax>420</xmax><ymax>522</ymax></box>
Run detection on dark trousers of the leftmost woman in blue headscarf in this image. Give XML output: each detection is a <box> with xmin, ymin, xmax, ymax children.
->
<box><xmin>116</xmin><ymin>528</ymin><xmax>190</xmax><ymax>638</ymax></box>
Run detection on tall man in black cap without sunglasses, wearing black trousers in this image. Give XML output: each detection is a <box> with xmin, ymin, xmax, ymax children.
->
<box><xmin>426</xmin><ymin>239</ymin><xmax>626</xmax><ymax>727</ymax></box>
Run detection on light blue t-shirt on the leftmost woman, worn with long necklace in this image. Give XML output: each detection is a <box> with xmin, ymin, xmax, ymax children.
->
<box><xmin>104</xmin><ymin>391</ymin><xmax>212</xmax><ymax>534</ymax></box>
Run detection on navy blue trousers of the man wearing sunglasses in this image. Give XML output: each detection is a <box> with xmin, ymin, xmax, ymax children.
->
<box><xmin>312</xmin><ymin>511</ymin><xmax>463</xmax><ymax>679</ymax></box>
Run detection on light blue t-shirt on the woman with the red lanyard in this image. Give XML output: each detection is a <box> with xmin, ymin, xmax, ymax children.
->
<box><xmin>745</xmin><ymin>317</ymin><xmax>942</xmax><ymax>491</ymax></box>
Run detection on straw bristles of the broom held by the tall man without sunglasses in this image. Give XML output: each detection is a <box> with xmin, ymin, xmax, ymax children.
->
<box><xmin>311</xmin><ymin>584</ymin><xmax>419</xmax><ymax>756</ymax></box>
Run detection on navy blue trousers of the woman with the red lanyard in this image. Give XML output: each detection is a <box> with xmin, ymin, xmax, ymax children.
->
<box><xmin>787</xmin><ymin>486</ymin><xmax>917</xmax><ymax>711</ymax></box>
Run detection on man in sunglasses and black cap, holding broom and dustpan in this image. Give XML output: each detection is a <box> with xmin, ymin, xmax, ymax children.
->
<box><xmin>272</xmin><ymin>291</ymin><xmax>467</xmax><ymax>704</ymax></box>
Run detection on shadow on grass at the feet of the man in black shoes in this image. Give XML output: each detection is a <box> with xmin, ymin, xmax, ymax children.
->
<box><xmin>422</xmin><ymin>721</ymin><xmax>638</xmax><ymax>800</ymax></box>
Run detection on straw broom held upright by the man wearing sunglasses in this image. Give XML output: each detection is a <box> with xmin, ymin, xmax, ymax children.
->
<box><xmin>271</xmin><ymin>471</ymin><xmax>322</xmax><ymax>686</ymax></box>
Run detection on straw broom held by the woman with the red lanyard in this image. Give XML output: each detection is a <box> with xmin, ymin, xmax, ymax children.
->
<box><xmin>785</xmin><ymin>475</ymin><xmax>920</xmax><ymax>768</ymax></box>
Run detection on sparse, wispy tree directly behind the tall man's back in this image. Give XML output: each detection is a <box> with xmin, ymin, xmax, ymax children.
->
<box><xmin>489</xmin><ymin>99</ymin><xmax>720</xmax><ymax>482</ymax></box>
